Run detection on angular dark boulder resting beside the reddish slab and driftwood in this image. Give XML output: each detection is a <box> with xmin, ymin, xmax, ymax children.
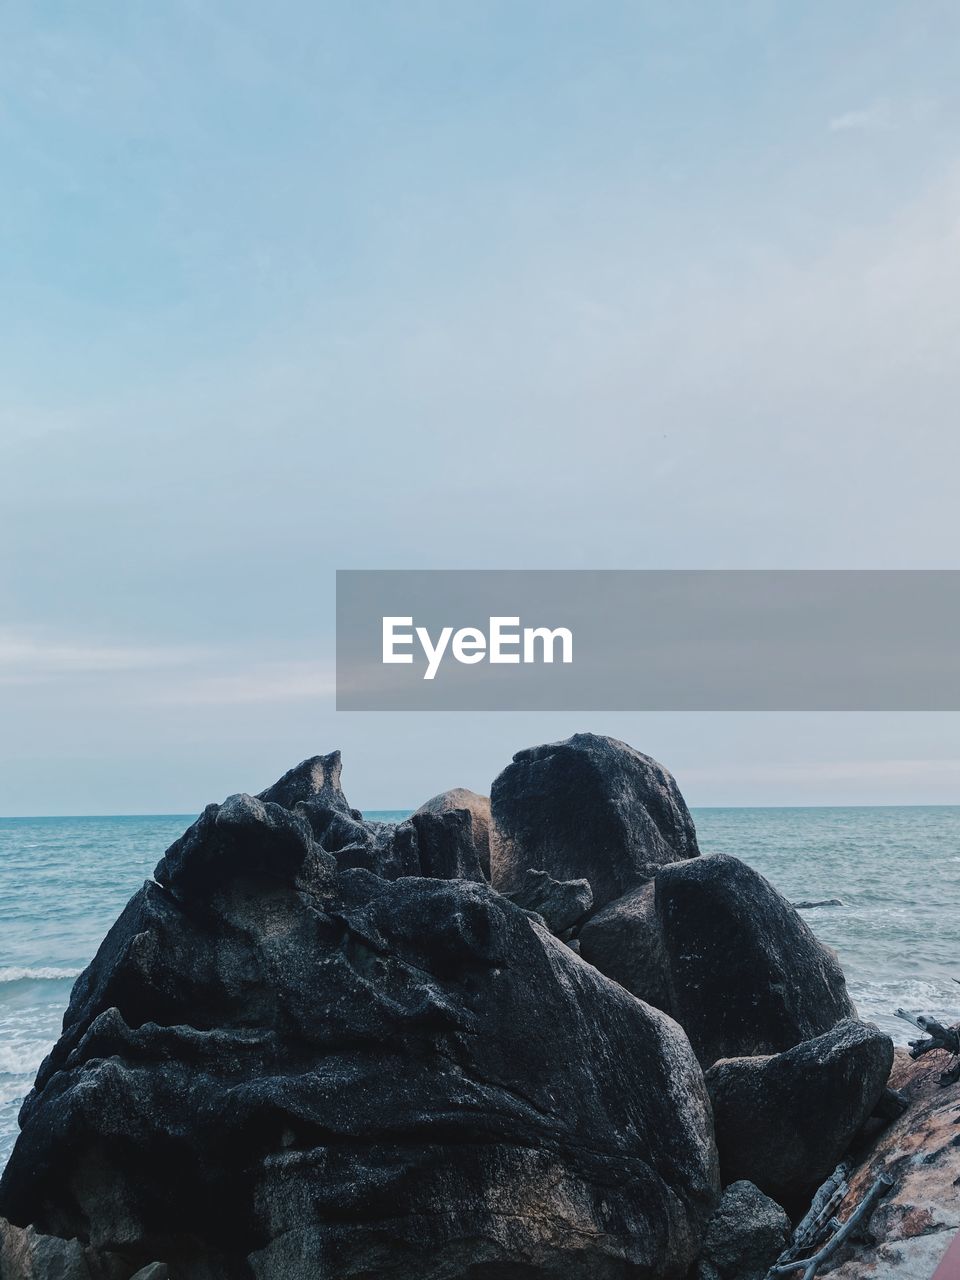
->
<box><xmin>707</xmin><ymin>1020</ymin><xmax>893</xmax><ymax>1212</ymax></box>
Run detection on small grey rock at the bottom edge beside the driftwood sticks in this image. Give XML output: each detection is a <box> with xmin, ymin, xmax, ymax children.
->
<box><xmin>698</xmin><ymin>1181</ymin><xmax>790</xmax><ymax>1280</ymax></box>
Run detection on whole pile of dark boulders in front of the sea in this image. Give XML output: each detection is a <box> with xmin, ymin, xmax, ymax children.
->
<box><xmin>0</xmin><ymin>733</ymin><xmax>911</xmax><ymax>1280</ymax></box>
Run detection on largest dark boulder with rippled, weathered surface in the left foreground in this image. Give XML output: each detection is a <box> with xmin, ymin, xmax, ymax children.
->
<box><xmin>0</xmin><ymin>757</ymin><xmax>718</xmax><ymax>1280</ymax></box>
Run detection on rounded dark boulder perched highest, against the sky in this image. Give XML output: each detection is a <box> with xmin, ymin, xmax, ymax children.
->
<box><xmin>490</xmin><ymin>733</ymin><xmax>699</xmax><ymax>908</ymax></box>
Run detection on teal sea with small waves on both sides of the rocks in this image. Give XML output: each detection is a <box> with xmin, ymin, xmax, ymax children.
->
<box><xmin>0</xmin><ymin>805</ymin><xmax>960</xmax><ymax>1169</ymax></box>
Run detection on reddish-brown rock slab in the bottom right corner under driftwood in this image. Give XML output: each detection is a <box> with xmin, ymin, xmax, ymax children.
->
<box><xmin>823</xmin><ymin>1050</ymin><xmax>960</xmax><ymax>1280</ymax></box>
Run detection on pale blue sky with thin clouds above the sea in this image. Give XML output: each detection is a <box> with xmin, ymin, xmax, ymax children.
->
<box><xmin>0</xmin><ymin>0</ymin><xmax>960</xmax><ymax>815</ymax></box>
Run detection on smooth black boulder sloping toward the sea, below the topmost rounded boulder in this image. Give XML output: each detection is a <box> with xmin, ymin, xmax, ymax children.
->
<box><xmin>643</xmin><ymin>854</ymin><xmax>856</xmax><ymax>1066</ymax></box>
